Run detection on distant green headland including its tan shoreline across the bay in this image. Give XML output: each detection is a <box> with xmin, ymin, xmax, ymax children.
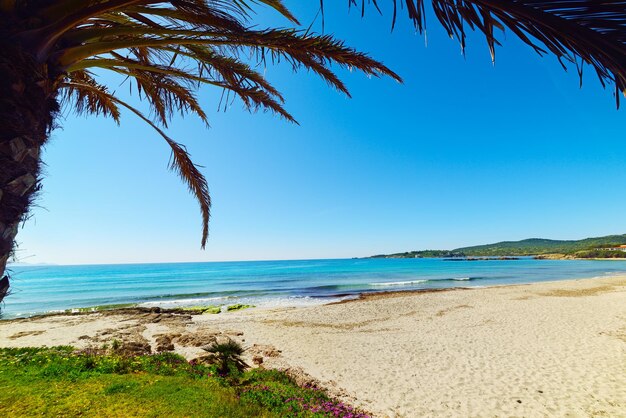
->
<box><xmin>367</xmin><ymin>234</ymin><xmax>626</xmax><ymax>260</ymax></box>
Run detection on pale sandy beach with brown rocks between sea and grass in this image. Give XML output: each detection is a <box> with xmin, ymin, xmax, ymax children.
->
<box><xmin>0</xmin><ymin>276</ymin><xmax>626</xmax><ymax>417</ymax></box>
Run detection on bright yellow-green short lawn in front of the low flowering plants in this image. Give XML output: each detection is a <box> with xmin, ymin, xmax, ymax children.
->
<box><xmin>0</xmin><ymin>374</ymin><xmax>262</xmax><ymax>417</ymax></box>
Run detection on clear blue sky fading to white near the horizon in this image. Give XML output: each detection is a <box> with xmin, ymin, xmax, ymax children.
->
<box><xmin>12</xmin><ymin>0</ymin><xmax>626</xmax><ymax>264</ymax></box>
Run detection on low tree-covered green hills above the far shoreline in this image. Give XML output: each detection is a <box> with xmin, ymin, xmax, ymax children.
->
<box><xmin>374</xmin><ymin>234</ymin><xmax>626</xmax><ymax>258</ymax></box>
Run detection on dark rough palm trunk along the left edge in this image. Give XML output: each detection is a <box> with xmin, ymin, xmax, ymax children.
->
<box><xmin>0</xmin><ymin>38</ymin><xmax>58</xmax><ymax>302</ymax></box>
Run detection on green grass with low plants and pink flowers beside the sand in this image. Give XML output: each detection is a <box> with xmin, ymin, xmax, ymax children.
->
<box><xmin>0</xmin><ymin>347</ymin><xmax>363</xmax><ymax>418</ymax></box>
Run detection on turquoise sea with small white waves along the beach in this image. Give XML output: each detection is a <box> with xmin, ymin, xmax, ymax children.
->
<box><xmin>2</xmin><ymin>258</ymin><xmax>626</xmax><ymax>319</ymax></box>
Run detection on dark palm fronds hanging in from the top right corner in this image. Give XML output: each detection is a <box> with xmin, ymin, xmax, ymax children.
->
<box><xmin>348</xmin><ymin>0</ymin><xmax>626</xmax><ymax>107</ymax></box>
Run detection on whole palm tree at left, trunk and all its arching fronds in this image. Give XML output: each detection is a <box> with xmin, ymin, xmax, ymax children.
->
<box><xmin>0</xmin><ymin>0</ymin><xmax>400</xmax><ymax>301</ymax></box>
